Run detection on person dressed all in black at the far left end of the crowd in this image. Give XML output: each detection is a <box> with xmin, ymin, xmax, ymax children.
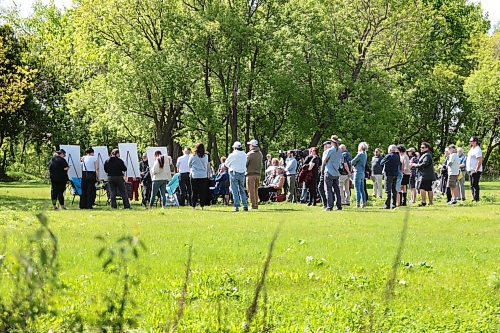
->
<box><xmin>49</xmin><ymin>149</ymin><xmax>69</xmax><ymax>209</ymax></box>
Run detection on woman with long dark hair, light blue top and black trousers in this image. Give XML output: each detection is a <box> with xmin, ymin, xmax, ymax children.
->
<box><xmin>189</xmin><ymin>142</ymin><xmax>210</xmax><ymax>209</ymax></box>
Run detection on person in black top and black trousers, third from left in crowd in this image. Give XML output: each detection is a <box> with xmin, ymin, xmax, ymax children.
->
<box><xmin>104</xmin><ymin>149</ymin><xmax>130</xmax><ymax>209</ymax></box>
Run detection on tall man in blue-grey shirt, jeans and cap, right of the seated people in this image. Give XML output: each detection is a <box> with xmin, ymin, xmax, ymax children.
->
<box><xmin>323</xmin><ymin>136</ymin><xmax>342</xmax><ymax>211</ymax></box>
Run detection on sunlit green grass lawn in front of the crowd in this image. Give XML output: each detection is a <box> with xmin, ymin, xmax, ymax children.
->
<box><xmin>0</xmin><ymin>182</ymin><xmax>500</xmax><ymax>332</ymax></box>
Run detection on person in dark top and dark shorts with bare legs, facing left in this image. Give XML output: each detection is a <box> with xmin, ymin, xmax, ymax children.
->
<box><xmin>410</xmin><ymin>142</ymin><xmax>436</xmax><ymax>207</ymax></box>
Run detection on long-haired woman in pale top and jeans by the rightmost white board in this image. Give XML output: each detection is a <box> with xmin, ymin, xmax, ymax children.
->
<box><xmin>149</xmin><ymin>150</ymin><xmax>172</xmax><ymax>209</ymax></box>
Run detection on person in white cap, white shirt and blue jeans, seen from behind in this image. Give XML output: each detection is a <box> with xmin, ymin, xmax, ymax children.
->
<box><xmin>224</xmin><ymin>141</ymin><xmax>248</xmax><ymax>212</ymax></box>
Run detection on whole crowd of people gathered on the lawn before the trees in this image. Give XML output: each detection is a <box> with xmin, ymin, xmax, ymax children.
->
<box><xmin>49</xmin><ymin>135</ymin><xmax>482</xmax><ymax>212</ymax></box>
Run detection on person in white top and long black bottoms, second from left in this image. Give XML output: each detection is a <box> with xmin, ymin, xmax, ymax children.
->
<box><xmin>80</xmin><ymin>147</ymin><xmax>99</xmax><ymax>209</ymax></box>
